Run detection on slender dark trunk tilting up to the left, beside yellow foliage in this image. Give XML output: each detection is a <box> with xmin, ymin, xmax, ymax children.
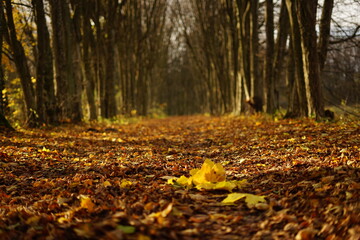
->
<box><xmin>5</xmin><ymin>0</ymin><xmax>37</xmax><ymax>127</ymax></box>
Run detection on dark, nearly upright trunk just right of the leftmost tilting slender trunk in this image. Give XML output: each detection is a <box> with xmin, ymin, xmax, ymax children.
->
<box><xmin>32</xmin><ymin>0</ymin><xmax>57</xmax><ymax>124</ymax></box>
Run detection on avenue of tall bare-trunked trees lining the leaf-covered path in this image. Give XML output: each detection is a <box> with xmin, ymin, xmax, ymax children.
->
<box><xmin>0</xmin><ymin>0</ymin><xmax>360</xmax><ymax>127</ymax></box>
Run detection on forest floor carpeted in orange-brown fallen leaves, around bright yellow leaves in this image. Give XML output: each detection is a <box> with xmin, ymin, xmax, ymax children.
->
<box><xmin>0</xmin><ymin>116</ymin><xmax>360</xmax><ymax>240</ymax></box>
